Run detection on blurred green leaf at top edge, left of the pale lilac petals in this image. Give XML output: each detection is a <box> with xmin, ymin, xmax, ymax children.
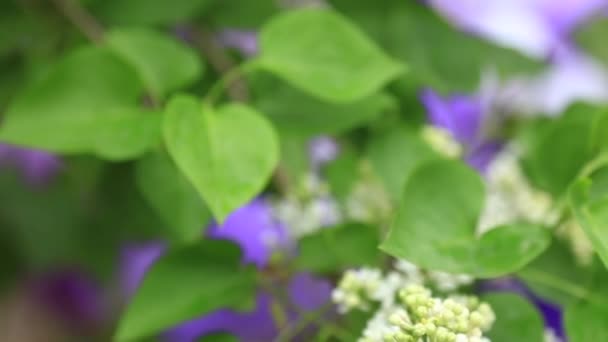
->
<box><xmin>330</xmin><ymin>0</ymin><xmax>542</xmax><ymax>93</ymax></box>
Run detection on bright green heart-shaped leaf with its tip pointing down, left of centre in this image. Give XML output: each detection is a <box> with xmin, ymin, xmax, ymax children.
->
<box><xmin>163</xmin><ymin>96</ymin><xmax>279</xmax><ymax>222</ymax></box>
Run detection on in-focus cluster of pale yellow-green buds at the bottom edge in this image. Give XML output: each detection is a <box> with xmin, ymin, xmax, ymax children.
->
<box><xmin>359</xmin><ymin>285</ymin><xmax>495</xmax><ymax>342</ymax></box>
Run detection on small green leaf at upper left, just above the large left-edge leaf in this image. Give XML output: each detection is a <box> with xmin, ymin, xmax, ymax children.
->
<box><xmin>105</xmin><ymin>28</ymin><xmax>203</xmax><ymax>97</ymax></box>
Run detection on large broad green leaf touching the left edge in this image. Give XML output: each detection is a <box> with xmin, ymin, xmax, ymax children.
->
<box><xmin>0</xmin><ymin>47</ymin><xmax>160</xmax><ymax>160</ymax></box>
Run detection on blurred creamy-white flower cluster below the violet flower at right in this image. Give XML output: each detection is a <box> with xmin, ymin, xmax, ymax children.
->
<box><xmin>477</xmin><ymin>147</ymin><xmax>557</xmax><ymax>234</ymax></box>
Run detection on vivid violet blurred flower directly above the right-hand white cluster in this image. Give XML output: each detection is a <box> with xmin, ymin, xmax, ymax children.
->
<box><xmin>420</xmin><ymin>89</ymin><xmax>502</xmax><ymax>172</ymax></box>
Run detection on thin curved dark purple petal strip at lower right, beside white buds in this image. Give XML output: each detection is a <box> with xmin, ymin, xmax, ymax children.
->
<box><xmin>479</xmin><ymin>278</ymin><xmax>565</xmax><ymax>340</ymax></box>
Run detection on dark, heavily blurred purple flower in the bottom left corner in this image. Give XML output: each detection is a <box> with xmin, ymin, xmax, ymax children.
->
<box><xmin>30</xmin><ymin>270</ymin><xmax>104</xmax><ymax>332</ymax></box>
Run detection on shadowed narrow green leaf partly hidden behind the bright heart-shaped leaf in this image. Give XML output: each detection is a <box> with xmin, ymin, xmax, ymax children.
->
<box><xmin>137</xmin><ymin>152</ymin><xmax>210</xmax><ymax>242</ymax></box>
